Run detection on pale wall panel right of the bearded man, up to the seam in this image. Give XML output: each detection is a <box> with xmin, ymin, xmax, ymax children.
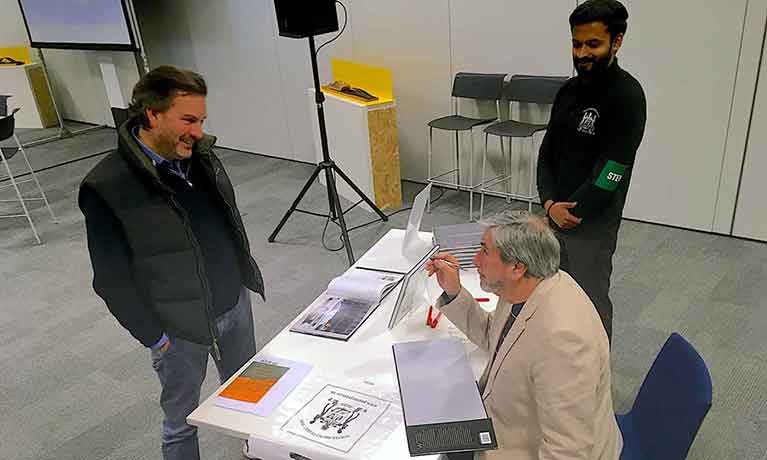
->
<box><xmin>620</xmin><ymin>0</ymin><xmax>746</xmax><ymax>231</ymax></box>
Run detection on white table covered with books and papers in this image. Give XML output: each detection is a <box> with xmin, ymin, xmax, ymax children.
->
<box><xmin>187</xmin><ymin>229</ymin><xmax>497</xmax><ymax>460</ymax></box>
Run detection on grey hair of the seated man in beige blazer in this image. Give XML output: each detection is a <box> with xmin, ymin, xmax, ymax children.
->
<box><xmin>480</xmin><ymin>211</ymin><xmax>559</xmax><ymax>279</ymax></box>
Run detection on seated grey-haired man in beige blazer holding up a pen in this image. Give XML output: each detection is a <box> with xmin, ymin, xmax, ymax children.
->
<box><xmin>426</xmin><ymin>212</ymin><xmax>623</xmax><ymax>460</ymax></box>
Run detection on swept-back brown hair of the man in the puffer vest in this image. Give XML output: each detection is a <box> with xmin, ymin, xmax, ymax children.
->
<box><xmin>128</xmin><ymin>65</ymin><xmax>208</xmax><ymax>128</ymax></box>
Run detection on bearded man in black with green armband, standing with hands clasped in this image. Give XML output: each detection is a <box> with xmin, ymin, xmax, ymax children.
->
<box><xmin>538</xmin><ymin>0</ymin><xmax>647</xmax><ymax>337</ymax></box>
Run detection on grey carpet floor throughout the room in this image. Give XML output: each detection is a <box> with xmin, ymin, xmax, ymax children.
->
<box><xmin>0</xmin><ymin>126</ymin><xmax>767</xmax><ymax>460</ymax></box>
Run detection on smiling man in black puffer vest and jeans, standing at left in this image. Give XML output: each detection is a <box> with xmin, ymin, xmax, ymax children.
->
<box><xmin>79</xmin><ymin>66</ymin><xmax>264</xmax><ymax>460</ymax></box>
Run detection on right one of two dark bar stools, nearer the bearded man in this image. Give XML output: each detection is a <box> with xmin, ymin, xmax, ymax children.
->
<box><xmin>479</xmin><ymin>75</ymin><xmax>568</xmax><ymax>218</ymax></box>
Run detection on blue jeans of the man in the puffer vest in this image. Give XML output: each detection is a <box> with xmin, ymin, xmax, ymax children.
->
<box><xmin>151</xmin><ymin>288</ymin><xmax>256</xmax><ymax>460</ymax></box>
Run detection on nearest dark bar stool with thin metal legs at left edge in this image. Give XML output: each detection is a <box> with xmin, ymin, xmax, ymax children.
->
<box><xmin>0</xmin><ymin>108</ymin><xmax>58</xmax><ymax>244</ymax></box>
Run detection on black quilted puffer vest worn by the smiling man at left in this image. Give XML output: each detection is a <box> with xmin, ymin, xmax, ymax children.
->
<box><xmin>82</xmin><ymin>120</ymin><xmax>264</xmax><ymax>352</ymax></box>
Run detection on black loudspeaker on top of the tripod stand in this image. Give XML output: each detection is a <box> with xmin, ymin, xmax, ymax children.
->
<box><xmin>274</xmin><ymin>0</ymin><xmax>338</xmax><ymax>38</ymax></box>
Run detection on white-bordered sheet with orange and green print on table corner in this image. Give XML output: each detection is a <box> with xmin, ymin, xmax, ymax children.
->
<box><xmin>214</xmin><ymin>356</ymin><xmax>312</xmax><ymax>417</ymax></box>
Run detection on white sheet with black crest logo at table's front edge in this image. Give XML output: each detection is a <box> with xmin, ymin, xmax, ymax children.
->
<box><xmin>282</xmin><ymin>385</ymin><xmax>392</xmax><ymax>453</ymax></box>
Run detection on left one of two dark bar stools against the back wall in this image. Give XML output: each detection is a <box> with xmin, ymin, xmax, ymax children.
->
<box><xmin>427</xmin><ymin>72</ymin><xmax>506</xmax><ymax>220</ymax></box>
